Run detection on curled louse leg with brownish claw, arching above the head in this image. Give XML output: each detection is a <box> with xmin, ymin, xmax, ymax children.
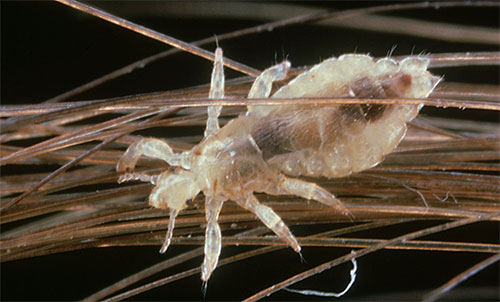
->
<box><xmin>116</xmin><ymin>138</ymin><xmax>190</xmax><ymax>172</ymax></box>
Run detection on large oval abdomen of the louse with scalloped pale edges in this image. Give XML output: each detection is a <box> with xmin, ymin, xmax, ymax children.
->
<box><xmin>249</xmin><ymin>54</ymin><xmax>440</xmax><ymax>177</ymax></box>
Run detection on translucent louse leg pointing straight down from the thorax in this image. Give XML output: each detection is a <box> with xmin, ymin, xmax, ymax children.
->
<box><xmin>201</xmin><ymin>196</ymin><xmax>224</xmax><ymax>282</ymax></box>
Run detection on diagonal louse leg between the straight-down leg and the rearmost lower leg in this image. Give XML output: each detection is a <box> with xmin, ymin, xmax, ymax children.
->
<box><xmin>236</xmin><ymin>194</ymin><xmax>300</xmax><ymax>253</ymax></box>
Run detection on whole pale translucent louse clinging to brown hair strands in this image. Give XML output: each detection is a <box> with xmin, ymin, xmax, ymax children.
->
<box><xmin>117</xmin><ymin>49</ymin><xmax>440</xmax><ymax>281</ymax></box>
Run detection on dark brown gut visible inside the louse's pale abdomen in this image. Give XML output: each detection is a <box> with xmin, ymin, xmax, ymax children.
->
<box><xmin>252</xmin><ymin>72</ymin><xmax>411</xmax><ymax>160</ymax></box>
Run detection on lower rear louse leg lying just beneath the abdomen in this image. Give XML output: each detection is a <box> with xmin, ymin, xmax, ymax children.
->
<box><xmin>276</xmin><ymin>175</ymin><xmax>350</xmax><ymax>215</ymax></box>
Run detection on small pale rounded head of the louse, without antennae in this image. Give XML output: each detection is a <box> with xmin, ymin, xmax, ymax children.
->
<box><xmin>149</xmin><ymin>169</ymin><xmax>201</xmax><ymax>210</ymax></box>
